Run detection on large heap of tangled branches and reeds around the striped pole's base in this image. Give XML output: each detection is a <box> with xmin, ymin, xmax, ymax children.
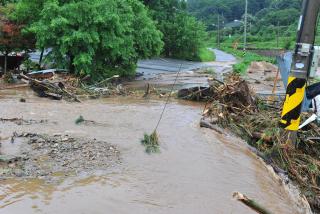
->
<box><xmin>203</xmin><ymin>76</ymin><xmax>320</xmax><ymax>212</ymax></box>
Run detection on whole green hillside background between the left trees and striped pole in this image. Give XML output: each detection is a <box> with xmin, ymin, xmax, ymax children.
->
<box><xmin>188</xmin><ymin>0</ymin><xmax>302</xmax><ymax>48</ymax></box>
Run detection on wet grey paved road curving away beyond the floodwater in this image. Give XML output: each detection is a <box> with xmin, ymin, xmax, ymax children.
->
<box><xmin>126</xmin><ymin>49</ymin><xmax>236</xmax><ymax>89</ymax></box>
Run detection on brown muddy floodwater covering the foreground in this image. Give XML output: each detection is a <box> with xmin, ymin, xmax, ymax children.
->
<box><xmin>0</xmin><ymin>88</ymin><xmax>308</xmax><ymax>214</ymax></box>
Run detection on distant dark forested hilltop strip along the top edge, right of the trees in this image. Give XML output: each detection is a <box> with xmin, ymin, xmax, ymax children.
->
<box><xmin>188</xmin><ymin>0</ymin><xmax>302</xmax><ymax>28</ymax></box>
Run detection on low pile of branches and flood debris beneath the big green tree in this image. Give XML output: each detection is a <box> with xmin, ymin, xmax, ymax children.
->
<box><xmin>1</xmin><ymin>69</ymin><xmax>130</xmax><ymax>102</ymax></box>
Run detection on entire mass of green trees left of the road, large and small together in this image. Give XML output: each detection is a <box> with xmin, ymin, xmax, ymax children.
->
<box><xmin>0</xmin><ymin>0</ymin><xmax>213</xmax><ymax>79</ymax></box>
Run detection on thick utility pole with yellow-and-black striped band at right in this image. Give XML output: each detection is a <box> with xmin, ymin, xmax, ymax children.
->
<box><xmin>280</xmin><ymin>0</ymin><xmax>320</xmax><ymax>133</ymax></box>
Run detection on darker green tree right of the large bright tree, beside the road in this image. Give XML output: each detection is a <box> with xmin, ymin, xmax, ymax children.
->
<box><xmin>143</xmin><ymin>0</ymin><xmax>207</xmax><ymax>60</ymax></box>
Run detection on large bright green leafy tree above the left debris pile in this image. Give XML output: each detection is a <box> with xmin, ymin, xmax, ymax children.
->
<box><xmin>31</xmin><ymin>0</ymin><xmax>163</xmax><ymax>78</ymax></box>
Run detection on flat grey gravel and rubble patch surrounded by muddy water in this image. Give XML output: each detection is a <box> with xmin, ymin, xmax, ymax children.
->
<box><xmin>0</xmin><ymin>133</ymin><xmax>120</xmax><ymax>178</ymax></box>
